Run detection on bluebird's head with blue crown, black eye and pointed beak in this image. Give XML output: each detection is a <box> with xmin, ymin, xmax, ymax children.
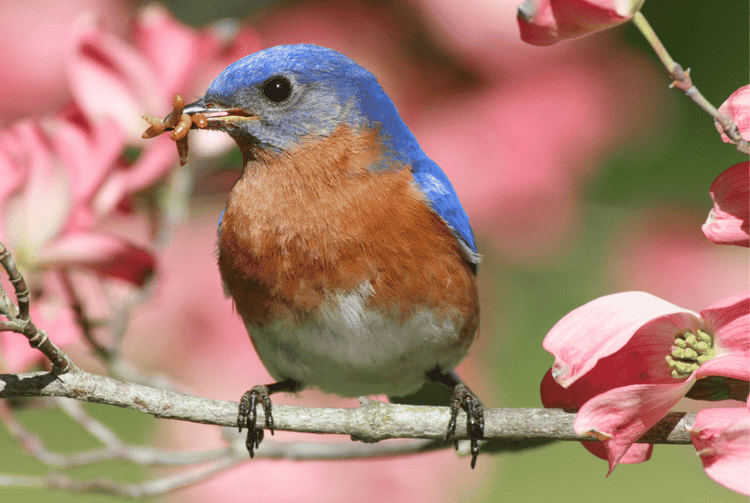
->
<box><xmin>185</xmin><ymin>44</ymin><xmax>424</xmax><ymax>164</ymax></box>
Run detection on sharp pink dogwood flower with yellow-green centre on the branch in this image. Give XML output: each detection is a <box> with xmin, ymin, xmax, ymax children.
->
<box><xmin>541</xmin><ymin>292</ymin><xmax>750</xmax><ymax>473</ymax></box>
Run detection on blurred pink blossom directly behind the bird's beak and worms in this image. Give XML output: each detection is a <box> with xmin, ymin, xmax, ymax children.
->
<box><xmin>67</xmin><ymin>5</ymin><xmax>260</xmax><ymax>211</ymax></box>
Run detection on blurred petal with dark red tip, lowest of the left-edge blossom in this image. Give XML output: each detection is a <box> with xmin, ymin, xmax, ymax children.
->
<box><xmin>37</xmin><ymin>233</ymin><xmax>156</xmax><ymax>285</ymax></box>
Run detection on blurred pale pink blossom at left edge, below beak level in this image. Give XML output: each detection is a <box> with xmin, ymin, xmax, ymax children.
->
<box><xmin>0</xmin><ymin>119</ymin><xmax>154</xmax><ymax>284</ymax></box>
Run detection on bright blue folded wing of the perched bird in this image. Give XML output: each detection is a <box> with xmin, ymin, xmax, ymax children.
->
<box><xmin>412</xmin><ymin>156</ymin><xmax>480</xmax><ymax>263</ymax></box>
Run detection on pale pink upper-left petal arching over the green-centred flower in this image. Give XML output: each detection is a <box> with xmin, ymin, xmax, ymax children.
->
<box><xmin>542</xmin><ymin>292</ymin><xmax>699</xmax><ymax>387</ymax></box>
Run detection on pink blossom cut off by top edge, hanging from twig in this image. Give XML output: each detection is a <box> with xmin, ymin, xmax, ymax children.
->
<box><xmin>518</xmin><ymin>0</ymin><xmax>643</xmax><ymax>45</ymax></box>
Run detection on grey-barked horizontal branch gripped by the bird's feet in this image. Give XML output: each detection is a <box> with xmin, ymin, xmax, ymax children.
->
<box><xmin>0</xmin><ymin>368</ymin><xmax>695</xmax><ymax>444</ymax></box>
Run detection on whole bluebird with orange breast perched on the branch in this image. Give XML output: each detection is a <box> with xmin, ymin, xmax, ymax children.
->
<box><xmin>173</xmin><ymin>44</ymin><xmax>484</xmax><ymax>467</ymax></box>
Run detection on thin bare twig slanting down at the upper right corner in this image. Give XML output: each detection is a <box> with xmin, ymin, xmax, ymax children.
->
<box><xmin>633</xmin><ymin>11</ymin><xmax>750</xmax><ymax>154</ymax></box>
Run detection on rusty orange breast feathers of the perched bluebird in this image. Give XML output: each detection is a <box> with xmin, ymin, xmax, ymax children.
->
<box><xmin>218</xmin><ymin>125</ymin><xmax>479</xmax><ymax>344</ymax></box>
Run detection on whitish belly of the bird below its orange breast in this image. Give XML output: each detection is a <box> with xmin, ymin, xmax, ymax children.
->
<box><xmin>247</xmin><ymin>284</ymin><xmax>471</xmax><ymax>397</ymax></box>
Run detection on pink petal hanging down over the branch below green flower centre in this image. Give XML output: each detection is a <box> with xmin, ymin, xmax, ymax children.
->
<box><xmin>575</xmin><ymin>379</ymin><xmax>694</xmax><ymax>475</ymax></box>
